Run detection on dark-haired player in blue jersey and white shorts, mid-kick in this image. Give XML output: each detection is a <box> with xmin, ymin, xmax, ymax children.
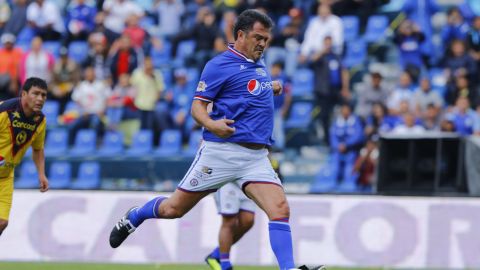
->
<box><xmin>110</xmin><ymin>10</ymin><xmax>324</xmax><ymax>270</ymax></box>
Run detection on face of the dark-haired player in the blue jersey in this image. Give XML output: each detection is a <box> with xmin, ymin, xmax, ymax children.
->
<box><xmin>240</xmin><ymin>22</ymin><xmax>271</xmax><ymax>61</ymax></box>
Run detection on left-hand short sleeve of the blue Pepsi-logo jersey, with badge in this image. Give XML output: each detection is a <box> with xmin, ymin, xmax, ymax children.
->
<box><xmin>193</xmin><ymin>62</ymin><xmax>226</xmax><ymax>102</ymax></box>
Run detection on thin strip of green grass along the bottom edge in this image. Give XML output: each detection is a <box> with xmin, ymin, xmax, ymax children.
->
<box><xmin>0</xmin><ymin>262</ymin><xmax>385</xmax><ymax>270</ymax></box>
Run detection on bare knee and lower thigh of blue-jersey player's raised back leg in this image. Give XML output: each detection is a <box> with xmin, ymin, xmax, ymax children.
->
<box><xmin>159</xmin><ymin>189</ymin><xmax>210</xmax><ymax>218</ymax></box>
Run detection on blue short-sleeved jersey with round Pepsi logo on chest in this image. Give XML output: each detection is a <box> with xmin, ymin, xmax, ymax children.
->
<box><xmin>194</xmin><ymin>46</ymin><xmax>274</xmax><ymax>145</ymax></box>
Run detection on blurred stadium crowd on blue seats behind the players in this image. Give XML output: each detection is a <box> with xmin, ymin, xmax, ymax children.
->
<box><xmin>0</xmin><ymin>0</ymin><xmax>480</xmax><ymax>191</ymax></box>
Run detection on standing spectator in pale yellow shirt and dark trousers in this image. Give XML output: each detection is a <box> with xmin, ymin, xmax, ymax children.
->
<box><xmin>130</xmin><ymin>57</ymin><xmax>165</xmax><ymax>137</ymax></box>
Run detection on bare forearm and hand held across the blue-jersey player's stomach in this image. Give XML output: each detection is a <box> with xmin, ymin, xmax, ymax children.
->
<box><xmin>192</xmin><ymin>100</ymin><xmax>235</xmax><ymax>139</ymax></box>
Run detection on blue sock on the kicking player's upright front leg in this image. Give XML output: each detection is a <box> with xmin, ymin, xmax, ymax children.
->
<box><xmin>268</xmin><ymin>218</ymin><xmax>295</xmax><ymax>270</ymax></box>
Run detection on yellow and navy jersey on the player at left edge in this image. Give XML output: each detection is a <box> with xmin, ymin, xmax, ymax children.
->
<box><xmin>0</xmin><ymin>98</ymin><xmax>46</xmax><ymax>179</ymax></box>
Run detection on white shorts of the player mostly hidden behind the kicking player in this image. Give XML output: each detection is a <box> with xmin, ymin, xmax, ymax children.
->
<box><xmin>215</xmin><ymin>183</ymin><xmax>245</xmax><ymax>216</ymax></box>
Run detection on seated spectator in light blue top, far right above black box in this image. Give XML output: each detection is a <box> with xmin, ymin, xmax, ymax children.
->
<box><xmin>445</xmin><ymin>96</ymin><xmax>476</xmax><ymax>136</ymax></box>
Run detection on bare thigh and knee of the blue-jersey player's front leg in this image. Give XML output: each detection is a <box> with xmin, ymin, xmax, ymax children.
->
<box><xmin>244</xmin><ymin>182</ymin><xmax>290</xmax><ymax>220</ymax></box>
